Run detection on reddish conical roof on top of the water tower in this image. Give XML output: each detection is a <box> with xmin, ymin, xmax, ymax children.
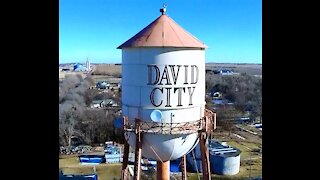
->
<box><xmin>118</xmin><ymin>8</ymin><xmax>207</xmax><ymax>49</ymax></box>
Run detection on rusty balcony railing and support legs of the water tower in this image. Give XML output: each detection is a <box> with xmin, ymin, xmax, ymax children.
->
<box><xmin>122</xmin><ymin>109</ymin><xmax>216</xmax><ymax>180</ymax></box>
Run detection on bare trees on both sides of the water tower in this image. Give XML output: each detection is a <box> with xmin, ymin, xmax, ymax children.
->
<box><xmin>59</xmin><ymin>74</ymin><xmax>262</xmax><ymax>146</ymax></box>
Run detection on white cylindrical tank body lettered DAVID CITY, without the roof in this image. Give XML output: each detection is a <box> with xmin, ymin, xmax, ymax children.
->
<box><xmin>122</xmin><ymin>48</ymin><xmax>205</xmax><ymax>161</ymax></box>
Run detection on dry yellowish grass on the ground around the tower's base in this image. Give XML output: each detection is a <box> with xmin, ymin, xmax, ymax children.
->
<box><xmin>59</xmin><ymin>126</ymin><xmax>262</xmax><ymax>180</ymax></box>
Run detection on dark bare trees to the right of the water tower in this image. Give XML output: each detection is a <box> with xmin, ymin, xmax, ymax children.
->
<box><xmin>206</xmin><ymin>73</ymin><xmax>262</xmax><ymax>132</ymax></box>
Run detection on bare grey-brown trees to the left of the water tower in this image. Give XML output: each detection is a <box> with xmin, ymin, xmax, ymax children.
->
<box><xmin>59</xmin><ymin>75</ymin><xmax>122</xmax><ymax>146</ymax></box>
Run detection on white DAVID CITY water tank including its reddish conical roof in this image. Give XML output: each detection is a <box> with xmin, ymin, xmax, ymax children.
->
<box><xmin>118</xmin><ymin>7</ymin><xmax>206</xmax><ymax>161</ymax></box>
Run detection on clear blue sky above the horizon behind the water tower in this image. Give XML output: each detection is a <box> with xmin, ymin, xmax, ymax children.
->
<box><xmin>59</xmin><ymin>0</ymin><xmax>262</xmax><ymax>63</ymax></box>
